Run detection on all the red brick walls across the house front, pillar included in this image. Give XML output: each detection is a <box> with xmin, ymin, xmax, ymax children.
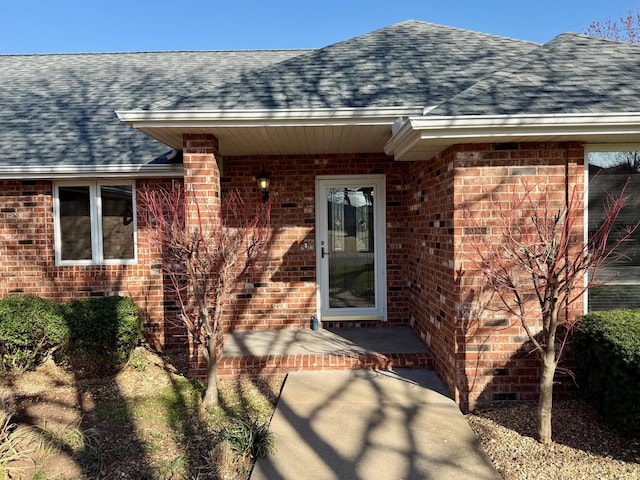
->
<box><xmin>0</xmin><ymin>136</ymin><xmax>584</xmax><ymax>406</ymax></box>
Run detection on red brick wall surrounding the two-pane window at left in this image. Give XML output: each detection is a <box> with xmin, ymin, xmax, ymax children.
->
<box><xmin>0</xmin><ymin>180</ymin><xmax>179</xmax><ymax>347</ymax></box>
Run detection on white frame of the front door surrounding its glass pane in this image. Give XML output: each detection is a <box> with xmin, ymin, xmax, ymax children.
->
<box><xmin>315</xmin><ymin>174</ymin><xmax>387</xmax><ymax>322</ymax></box>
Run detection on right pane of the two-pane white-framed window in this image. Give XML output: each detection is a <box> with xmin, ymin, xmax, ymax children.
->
<box><xmin>100</xmin><ymin>185</ymin><xmax>134</xmax><ymax>260</ymax></box>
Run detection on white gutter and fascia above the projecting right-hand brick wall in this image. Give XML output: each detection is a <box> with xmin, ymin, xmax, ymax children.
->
<box><xmin>385</xmin><ymin>112</ymin><xmax>640</xmax><ymax>157</ymax></box>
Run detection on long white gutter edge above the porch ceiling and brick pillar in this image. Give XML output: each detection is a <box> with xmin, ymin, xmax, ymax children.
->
<box><xmin>115</xmin><ymin>106</ymin><xmax>425</xmax><ymax>128</ymax></box>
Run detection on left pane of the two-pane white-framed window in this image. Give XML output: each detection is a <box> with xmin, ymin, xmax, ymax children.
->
<box><xmin>58</xmin><ymin>186</ymin><xmax>91</xmax><ymax>260</ymax></box>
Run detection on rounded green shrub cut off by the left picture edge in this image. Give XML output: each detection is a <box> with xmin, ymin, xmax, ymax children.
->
<box><xmin>0</xmin><ymin>295</ymin><xmax>68</xmax><ymax>372</ymax></box>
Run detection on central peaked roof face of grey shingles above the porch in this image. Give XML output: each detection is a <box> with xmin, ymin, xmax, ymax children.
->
<box><xmin>162</xmin><ymin>20</ymin><xmax>538</xmax><ymax>110</ymax></box>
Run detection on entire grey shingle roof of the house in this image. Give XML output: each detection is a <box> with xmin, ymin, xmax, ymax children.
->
<box><xmin>0</xmin><ymin>20</ymin><xmax>640</xmax><ymax>171</ymax></box>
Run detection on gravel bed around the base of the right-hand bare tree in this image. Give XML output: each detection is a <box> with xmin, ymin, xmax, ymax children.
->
<box><xmin>467</xmin><ymin>400</ymin><xmax>640</xmax><ymax>480</ymax></box>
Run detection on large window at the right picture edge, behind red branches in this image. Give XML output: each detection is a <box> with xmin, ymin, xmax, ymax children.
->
<box><xmin>587</xmin><ymin>151</ymin><xmax>640</xmax><ymax>311</ymax></box>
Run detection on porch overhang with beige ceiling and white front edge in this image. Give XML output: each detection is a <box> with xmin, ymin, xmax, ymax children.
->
<box><xmin>116</xmin><ymin>107</ymin><xmax>424</xmax><ymax>156</ymax></box>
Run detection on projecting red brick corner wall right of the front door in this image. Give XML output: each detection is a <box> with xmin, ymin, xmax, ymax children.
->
<box><xmin>407</xmin><ymin>143</ymin><xmax>584</xmax><ymax>408</ymax></box>
